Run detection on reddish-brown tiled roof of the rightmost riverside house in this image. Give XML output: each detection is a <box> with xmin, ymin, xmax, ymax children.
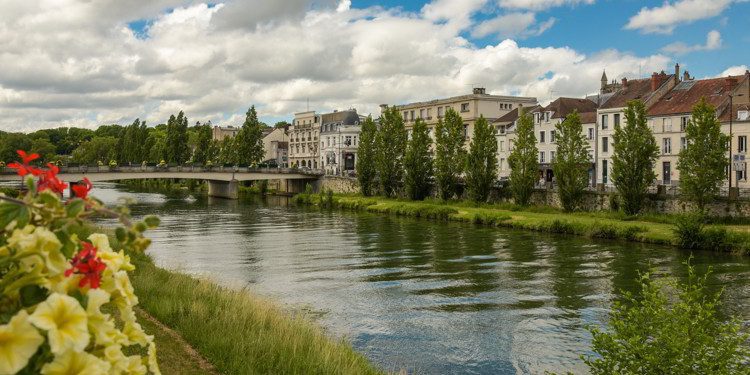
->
<box><xmin>648</xmin><ymin>75</ymin><xmax>748</xmax><ymax>120</ymax></box>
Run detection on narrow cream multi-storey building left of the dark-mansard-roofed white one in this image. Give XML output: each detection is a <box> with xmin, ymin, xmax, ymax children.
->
<box><xmin>288</xmin><ymin>111</ymin><xmax>320</xmax><ymax>169</ymax></box>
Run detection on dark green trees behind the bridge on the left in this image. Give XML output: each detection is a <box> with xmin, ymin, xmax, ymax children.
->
<box><xmin>0</xmin><ymin>106</ymin><xmax>268</xmax><ymax>165</ymax></box>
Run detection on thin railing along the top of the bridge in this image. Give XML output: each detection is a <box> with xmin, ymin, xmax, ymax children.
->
<box><xmin>0</xmin><ymin>165</ymin><xmax>325</xmax><ymax>176</ymax></box>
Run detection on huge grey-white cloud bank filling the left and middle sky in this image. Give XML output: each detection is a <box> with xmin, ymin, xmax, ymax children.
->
<box><xmin>0</xmin><ymin>0</ymin><xmax>680</xmax><ymax>131</ymax></box>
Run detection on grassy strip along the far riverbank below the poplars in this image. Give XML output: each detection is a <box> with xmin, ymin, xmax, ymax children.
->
<box><xmin>294</xmin><ymin>194</ymin><xmax>750</xmax><ymax>253</ymax></box>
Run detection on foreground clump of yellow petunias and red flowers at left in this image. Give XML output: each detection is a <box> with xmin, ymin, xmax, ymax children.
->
<box><xmin>0</xmin><ymin>151</ymin><xmax>159</xmax><ymax>374</ymax></box>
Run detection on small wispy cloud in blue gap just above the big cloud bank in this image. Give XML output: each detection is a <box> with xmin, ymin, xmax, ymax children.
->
<box><xmin>471</xmin><ymin>12</ymin><xmax>555</xmax><ymax>38</ymax></box>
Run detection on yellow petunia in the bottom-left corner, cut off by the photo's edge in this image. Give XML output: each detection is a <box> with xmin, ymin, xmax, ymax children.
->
<box><xmin>0</xmin><ymin>310</ymin><xmax>44</xmax><ymax>374</ymax></box>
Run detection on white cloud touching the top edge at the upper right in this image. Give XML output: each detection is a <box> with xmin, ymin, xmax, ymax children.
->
<box><xmin>625</xmin><ymin>0</ymin><xmax>736</xmax><ymax>34</ymax></box>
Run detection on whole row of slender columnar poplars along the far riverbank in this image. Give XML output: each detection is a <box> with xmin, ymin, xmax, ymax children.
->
<box><xmin>357</xmin><ymin>98</ymin><xmax>729</xmax><ymax>215</ymax></box>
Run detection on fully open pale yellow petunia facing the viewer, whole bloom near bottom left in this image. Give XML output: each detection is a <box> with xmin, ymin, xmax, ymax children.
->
<box><xmin>29</xmin><ymin>293</ymin><xmax>89</xmax><ymax>354</ymax></box>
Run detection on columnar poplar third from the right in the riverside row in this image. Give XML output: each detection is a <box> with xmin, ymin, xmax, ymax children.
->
<box><xmin>552</xmin><ymin>111</ymin><xmax>591</xmax><ymax>211</ymax></box>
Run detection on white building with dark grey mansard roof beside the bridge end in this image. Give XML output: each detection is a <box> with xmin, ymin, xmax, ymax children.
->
<box><xmin>320</xmin><ymin>109</ymin><xmax>363</xmax><ymax>175</ymax></box>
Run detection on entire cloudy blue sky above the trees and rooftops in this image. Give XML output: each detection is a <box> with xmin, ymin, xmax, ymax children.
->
<box><xmin>0</xmin><ymin>0</ymin><xmax>750</xmax><ymax>132</ymax></box>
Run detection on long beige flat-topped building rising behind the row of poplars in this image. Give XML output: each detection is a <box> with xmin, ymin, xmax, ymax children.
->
<box><xmin>388</xmin><ymin>88</ymin><xmax>537</xmax><ymax>145</ymax></box>
